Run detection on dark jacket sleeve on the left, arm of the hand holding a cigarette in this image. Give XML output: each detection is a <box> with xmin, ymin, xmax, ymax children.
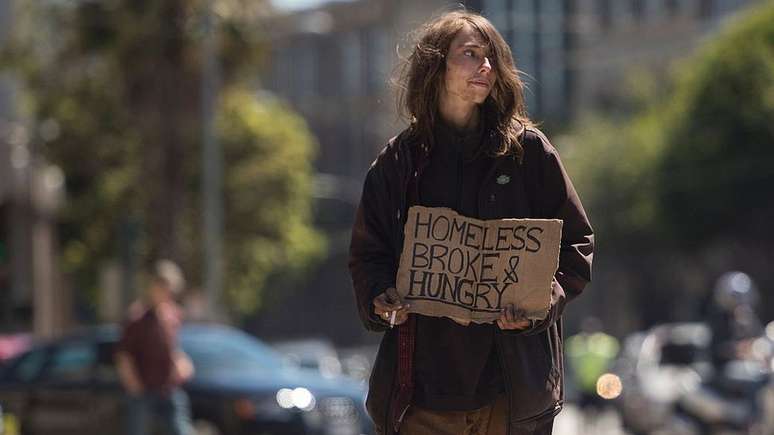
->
<box><xmin>349</xmin><ymin>159</ymin><xmax>399</xmax><ymax>331</ymax></box>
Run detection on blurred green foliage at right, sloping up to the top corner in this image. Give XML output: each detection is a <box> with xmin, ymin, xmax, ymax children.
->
<box><xmin>566</xmin><ymin>2</ymin><xmax>774</xmax><ymax>246</ymax></box>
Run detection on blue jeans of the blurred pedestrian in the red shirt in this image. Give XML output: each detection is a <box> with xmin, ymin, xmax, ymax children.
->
<box><xmin>126</xmin><ymin>388</ymin><xmax>192</xmax><ymax>435</ymax></box>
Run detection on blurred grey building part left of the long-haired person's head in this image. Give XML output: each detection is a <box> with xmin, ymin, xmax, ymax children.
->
<box><xmin>262</xmin><ymin>0</ymin><xmax>446</xmax><ymax>184</ymax></box>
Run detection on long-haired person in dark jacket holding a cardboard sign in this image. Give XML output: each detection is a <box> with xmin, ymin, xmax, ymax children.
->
<box><xmin>350</xmin><ymin>11</ymin><xmax>594</xmax><ymax>435</ymax></box>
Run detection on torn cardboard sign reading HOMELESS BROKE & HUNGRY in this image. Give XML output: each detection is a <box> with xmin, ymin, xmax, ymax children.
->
<box><xmin>397</xmin><ymin>206</ymin><xmax>562</xmax><ymax>324</ymax></box>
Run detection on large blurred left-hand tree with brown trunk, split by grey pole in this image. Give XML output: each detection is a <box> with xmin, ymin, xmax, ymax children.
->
<box><xmin>5</xmin><ymin>0</ymin><xmax>323</xmax><ymax>312</ymax></box>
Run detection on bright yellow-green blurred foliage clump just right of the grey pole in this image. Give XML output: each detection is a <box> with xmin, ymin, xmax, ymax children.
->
<box><xmin>218</xmin><ymin>91</ymin><xmax>324</xmax><ymax>312</ymax></box>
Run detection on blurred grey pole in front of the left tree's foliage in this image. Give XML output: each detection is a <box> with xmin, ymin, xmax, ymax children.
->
<box><xmin>201</xmin><ymin>2</ymin><xmax>223</xmax><ymax>316</ymax></box>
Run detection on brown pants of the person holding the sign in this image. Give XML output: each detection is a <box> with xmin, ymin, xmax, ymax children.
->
<box><xmin>400</xmin><ymin>395</ymin><xmax>554</xmax><ymax>435</ymax></box>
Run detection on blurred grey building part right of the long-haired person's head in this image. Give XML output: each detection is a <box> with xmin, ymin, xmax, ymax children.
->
<box><xmin>480</xmin><ymin>0</ymin><xmax>756</xmax><ymax>121</ymax></box>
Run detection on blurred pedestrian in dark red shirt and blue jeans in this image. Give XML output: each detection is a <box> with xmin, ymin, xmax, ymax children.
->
<box><xmin>116</xmin><ymin>260</ymin><xmax>199</xmax><ymax>435</ymax></box>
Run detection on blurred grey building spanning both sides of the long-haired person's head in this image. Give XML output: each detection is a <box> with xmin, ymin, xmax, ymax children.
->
<box><xmin>262</xmin><ymin>0</ymin><xmax>756</xmax><ymax>184</ymax></box>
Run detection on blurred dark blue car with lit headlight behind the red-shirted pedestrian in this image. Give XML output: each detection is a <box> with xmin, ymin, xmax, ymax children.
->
<box><xmin>0</xmin><ymin>324</ymin><xmax>372</xmax><ymax>435</ymax></box>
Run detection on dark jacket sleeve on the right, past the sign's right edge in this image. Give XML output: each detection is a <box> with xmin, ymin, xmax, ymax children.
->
<box><xmin>506</xmin><ymin>133</ymin><xmax>594</xmax><ymax>335</ymax></box>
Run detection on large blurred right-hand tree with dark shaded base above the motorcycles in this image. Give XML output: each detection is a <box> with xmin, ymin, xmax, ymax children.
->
<box><xmin>557</xmin><ymin>2</ymin><xmax>774</xmax><ymax>326</ymax></box>
